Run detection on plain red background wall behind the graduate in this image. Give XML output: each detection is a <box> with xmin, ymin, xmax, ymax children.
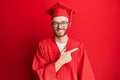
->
<box><xmin>0</xmin><ymin>0</ymin><xmax>120</xmax><ymax>80</ymax></box>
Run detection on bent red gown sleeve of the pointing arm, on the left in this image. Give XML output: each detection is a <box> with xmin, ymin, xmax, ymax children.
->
<box><xmin>32</xmin><ymin>43</ymin><xmax>56</xmax><ymax>80</ymax></box>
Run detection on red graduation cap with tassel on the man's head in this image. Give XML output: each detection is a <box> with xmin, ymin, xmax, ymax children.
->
<box><xmin>46</xmin><ymin>1</ymin><xmax>75</xmax><ymax>21</ymax></box>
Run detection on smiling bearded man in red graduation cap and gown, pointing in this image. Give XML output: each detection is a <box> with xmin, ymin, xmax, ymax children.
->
<box><xmin>32</xmin><ymin>2</ymin><xmax>95</xmax><ymax>80</ymax></box>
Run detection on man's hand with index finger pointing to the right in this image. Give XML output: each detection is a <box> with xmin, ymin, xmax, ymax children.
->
<box><xmin>57</xmin><ymin>48</ymin><xmax>78</xmax><ymax>65</ymax></box>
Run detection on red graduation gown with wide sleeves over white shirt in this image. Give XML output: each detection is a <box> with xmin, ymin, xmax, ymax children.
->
<box><xmin>32</xmin><ymin>38</ymin><xmax>95</xmax><ymax>80</ymax></box>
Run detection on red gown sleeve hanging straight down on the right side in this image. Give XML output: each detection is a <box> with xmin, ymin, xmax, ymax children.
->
<box><xmin>78</xmin><ymin>44</ymin><xmax>95</xmax><ymax>80</ymax></box>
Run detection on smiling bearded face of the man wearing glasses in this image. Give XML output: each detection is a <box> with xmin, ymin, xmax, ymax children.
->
<box><xmin>52</xmin><ymin>16</ymin><xmax>68</xmax><ymax>37</ymax></box>
